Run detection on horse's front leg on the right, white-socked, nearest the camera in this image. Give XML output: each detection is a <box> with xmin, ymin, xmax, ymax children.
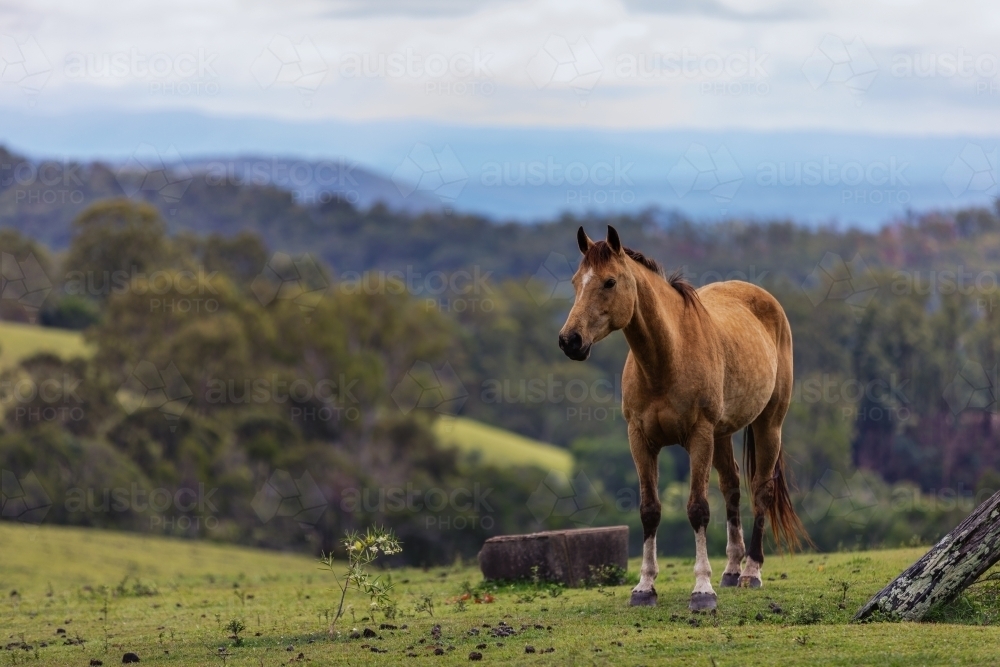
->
<box><xmin>687</xmin><ymin>424</ymin><xmax>717</xmax><ymax>611</ymax></box>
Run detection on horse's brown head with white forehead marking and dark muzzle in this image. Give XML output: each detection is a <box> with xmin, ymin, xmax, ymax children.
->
<box><xmin>559</xmin><ymin>225</ymin><xmax>636</xmax><ymax>361</ymax></box>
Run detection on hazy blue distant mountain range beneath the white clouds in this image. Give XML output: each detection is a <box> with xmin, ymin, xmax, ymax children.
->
<box><xmin>0</xmin><ymin>108</ymin><xmax>1000</xmax><ymax>229</ymax></box>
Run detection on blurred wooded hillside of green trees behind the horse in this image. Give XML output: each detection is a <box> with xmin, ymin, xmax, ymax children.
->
<box><xmin>0</xmin><ymin>146</ymin><xmax>1000</xmax><ymax>564</ymax></box>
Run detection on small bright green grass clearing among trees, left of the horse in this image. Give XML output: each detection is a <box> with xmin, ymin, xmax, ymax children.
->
<box><xmin>434</xmin><ymin>417</ymin><xmax>573</xmax><ymax>474</ymax></box>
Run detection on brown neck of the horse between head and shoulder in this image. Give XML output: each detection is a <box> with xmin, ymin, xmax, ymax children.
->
<box><xmin>622</xmin><ymin>268</ymin><xmax>684</xmax><ymax>380</ymax></box>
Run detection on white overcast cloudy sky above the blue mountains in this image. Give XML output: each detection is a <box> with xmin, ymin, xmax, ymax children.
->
<box><xmin>0</xmin><ymin>0</ymin><xmax>1000</xmax><ymax>136</ymax></box>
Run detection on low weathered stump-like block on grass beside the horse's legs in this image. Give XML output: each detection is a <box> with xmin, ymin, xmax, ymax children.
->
<box><xmin>479</xmin><ymin>526</ymin><xmax>628</xmax><ymax>587</ymax></box>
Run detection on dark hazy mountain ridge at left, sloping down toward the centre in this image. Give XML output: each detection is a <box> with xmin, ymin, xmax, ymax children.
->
<box><xmin>0</xmin><ymin>146</ymin><xmax>444</xmax><ymax>249</ymax></box>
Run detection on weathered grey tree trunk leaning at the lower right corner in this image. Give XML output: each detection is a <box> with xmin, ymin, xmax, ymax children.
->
<box><xmin>854</xmin><ymin>492</ymin><xmax>1000</xmax><ymax>621</ymax></box>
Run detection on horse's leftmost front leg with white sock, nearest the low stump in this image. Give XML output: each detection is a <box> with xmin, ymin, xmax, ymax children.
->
<box><xmin>628</xmin><ymin>425</ymin><xmax>660</xmax><ymax>607</ymax></box>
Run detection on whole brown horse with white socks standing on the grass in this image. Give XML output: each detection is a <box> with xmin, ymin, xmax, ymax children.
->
<box><xmin>559</xmin><ymin>226</ymin><xmax>808</xmax><ymax>610</ymax></box>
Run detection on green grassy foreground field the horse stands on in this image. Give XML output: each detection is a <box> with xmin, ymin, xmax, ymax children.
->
<box><xmin>0</xmin><ymin>523</ymin><xmax>1000</xmax><ymax>667</ymax></box>
